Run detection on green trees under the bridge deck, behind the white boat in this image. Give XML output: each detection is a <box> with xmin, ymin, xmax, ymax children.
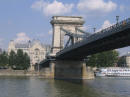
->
<box><xmin>86</xmin><ymin>50</ymin><xmax>119</xmax><ymax>67</ymax></box>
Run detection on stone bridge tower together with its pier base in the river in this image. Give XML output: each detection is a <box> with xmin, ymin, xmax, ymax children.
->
<box><xmin>39</xmin><ymin>16</ymin><xmax>94</xmax><ymax>79</ymax></box>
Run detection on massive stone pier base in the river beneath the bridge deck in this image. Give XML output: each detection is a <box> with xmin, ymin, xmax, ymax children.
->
<box><xmin>50</xmin><ymin>60</ymin><xmax>94</xmax><ymax>79</ymax></box>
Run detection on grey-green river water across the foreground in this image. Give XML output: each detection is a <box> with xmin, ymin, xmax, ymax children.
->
<box><xmin>0</xmin><ymin>77</ymin><xmax>130</xmax><ymax>97</ymax></box>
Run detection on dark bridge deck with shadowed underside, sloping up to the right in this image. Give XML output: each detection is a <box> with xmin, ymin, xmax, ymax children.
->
<box><xmin>56</xmin><ymin>18</ymin><xmax>130</xmax><ymax>60</ymax></box>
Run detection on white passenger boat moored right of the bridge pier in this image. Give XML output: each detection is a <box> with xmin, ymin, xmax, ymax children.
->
<box><xmin>95</xmin><ymin>67</ymin><xmax>130</xmax><ymax>77</ymax></box>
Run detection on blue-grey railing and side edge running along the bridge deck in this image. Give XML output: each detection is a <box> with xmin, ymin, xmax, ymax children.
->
<box><xmin>57</xmin><ymin>18</ymin><xmax>130</xmax><ymax>53</ymax></box>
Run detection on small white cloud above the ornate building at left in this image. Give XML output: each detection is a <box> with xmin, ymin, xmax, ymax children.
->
<box><xmin>14</xmin><ymin>32</ymin><xmax>30</xmax><ymax>43</ymax></box>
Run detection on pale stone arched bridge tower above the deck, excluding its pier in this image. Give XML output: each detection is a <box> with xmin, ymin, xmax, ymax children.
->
<box><xmin>51</xmin><ymin>16</ymin><xmax>84</xmax><ymax>56</ymax></box>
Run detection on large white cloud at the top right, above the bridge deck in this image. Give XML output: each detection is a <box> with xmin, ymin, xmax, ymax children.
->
<box><xmin>77</xmin><ymin>0</ymin><xmax>117</xmax><ymax>13</ymax></box>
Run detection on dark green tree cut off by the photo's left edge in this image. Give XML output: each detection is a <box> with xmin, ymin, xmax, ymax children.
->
<box><xmin>0</xmin><ymin>51</ymin><xmax>8</xmax><ymax>67</ymax></box>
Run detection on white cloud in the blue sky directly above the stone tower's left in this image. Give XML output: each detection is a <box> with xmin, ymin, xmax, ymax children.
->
<box><xmin>31</xmin><ymin>0</ymin><xmax>74</xmax><ymax>16</ymax></box>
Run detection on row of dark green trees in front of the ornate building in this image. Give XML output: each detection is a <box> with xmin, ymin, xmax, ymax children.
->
<box><xmin>0</xmin><ymin>49</ymin><xmax>30</xmax><ymax>70</ymax></box>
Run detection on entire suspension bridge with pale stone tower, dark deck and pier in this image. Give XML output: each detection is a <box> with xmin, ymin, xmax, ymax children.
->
<box><xmin>40</xmin><ymin>16</ymin><xmax>130</xmax><ymax>79</ymax></box>
